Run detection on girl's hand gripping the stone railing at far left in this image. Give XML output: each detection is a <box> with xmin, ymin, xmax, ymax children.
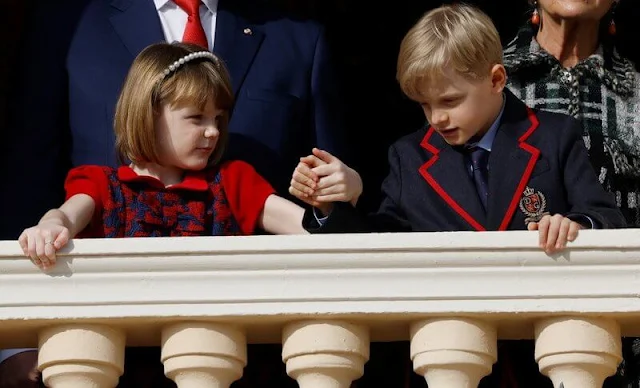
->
<box><xmin>18</xmin><ymin>222</ymin><xmax>69</xmax><ymax>270</ymax></box>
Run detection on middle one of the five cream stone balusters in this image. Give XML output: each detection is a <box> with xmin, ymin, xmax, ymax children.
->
<box><xmin>282</xmin><ymin>321</ymin><xmax>369</xmax><ymax>388</ymax></box>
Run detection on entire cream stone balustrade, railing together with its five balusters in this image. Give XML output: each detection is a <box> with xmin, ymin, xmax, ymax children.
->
<box><xmin>0</xmin><ymin>230</ymin><xmax>640</xmax><ymax>388</ymax></box>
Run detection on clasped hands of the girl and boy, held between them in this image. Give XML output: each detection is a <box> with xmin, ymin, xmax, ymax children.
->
<box><xmin>289</xmin><ymin>148</ymin><xmax>362</xmax><ymax>206</ymax></box>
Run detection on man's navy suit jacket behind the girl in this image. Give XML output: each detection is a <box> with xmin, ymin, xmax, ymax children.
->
<box><xmin>0</xmin><ymin>0</ymin><xmax>348</xmax><ymax>238</ymax></box>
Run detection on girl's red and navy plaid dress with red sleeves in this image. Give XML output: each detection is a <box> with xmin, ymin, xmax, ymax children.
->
<box><xmin>65</xmin><ymin>161</ymin><xmax>274</xmax><ymax>238</ymax></box>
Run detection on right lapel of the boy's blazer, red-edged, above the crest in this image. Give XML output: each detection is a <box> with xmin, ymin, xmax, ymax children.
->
<box><xmin>487</xmin><ymin>91</ymin><xmax>540</xmax><ymax>230</ymax></box>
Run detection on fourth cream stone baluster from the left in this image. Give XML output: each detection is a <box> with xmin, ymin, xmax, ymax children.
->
<box><xmin>411</xmin><ymin>318</ymin><xmax>497</xmax><ymax>388</ymax></box>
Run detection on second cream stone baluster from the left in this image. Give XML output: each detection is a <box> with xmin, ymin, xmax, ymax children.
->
<box><xmin>161</xmin><ymin>322</ymin><xmax>247</xmax><ymax>388</ymax></box>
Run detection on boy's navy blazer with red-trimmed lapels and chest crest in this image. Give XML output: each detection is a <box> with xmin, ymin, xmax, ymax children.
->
<box><xmin>304</xmin><ymin>91</ymin><xmax>626</xmax><ymax>233</ymax></box>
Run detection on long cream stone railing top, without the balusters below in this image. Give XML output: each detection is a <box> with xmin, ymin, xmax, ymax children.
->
<box><xmin>0</xmin><ymin>229</ymin><xmax>640</xmax><ymax>344</ymax></box>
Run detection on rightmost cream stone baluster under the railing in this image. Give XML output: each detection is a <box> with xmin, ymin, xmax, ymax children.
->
<box><xmin>535</xmin><ymin>317</ymin><xmax>622</xmax><ymax>388</ymax></box>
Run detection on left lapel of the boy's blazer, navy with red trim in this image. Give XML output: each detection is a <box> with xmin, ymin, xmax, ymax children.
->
<box><xmin>420</xmin><ymin>128</ymin><xmax>486</xmax><ymax>231</ymax></box>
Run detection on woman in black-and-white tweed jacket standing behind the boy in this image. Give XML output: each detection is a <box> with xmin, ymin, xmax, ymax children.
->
<box><xmin>504</xmin><ymin>0</ymin><xmax>640</xmax><ymax>388</ymax></box>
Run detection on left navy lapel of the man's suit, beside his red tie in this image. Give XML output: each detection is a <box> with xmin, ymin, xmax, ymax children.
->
<box><xmin>109</xmin><ymin>0</ymin><xmax>165</xmax><ymax>57</ymax></box>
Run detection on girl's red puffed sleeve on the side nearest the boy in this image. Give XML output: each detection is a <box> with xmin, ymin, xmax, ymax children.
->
<box><xmin>220</xmin><ymin>161</ymin><xmax>275</xmax><ymax>235</ymax></box>
